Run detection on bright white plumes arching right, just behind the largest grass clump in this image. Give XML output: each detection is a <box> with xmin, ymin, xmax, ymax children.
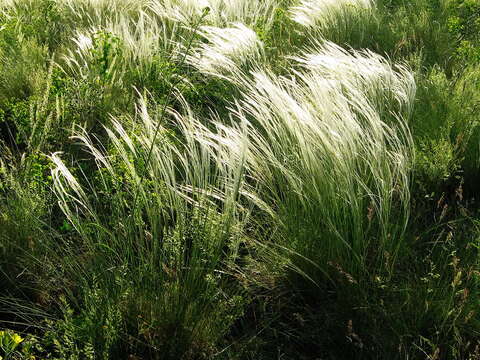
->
<box><xmin>292</xmin><ymin>41</ymin><xmax>416</xmax><ymax>118</ymax></box>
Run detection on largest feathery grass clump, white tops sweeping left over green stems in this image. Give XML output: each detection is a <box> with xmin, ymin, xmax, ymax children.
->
<box><xmin>218</xmin><ymin>58</ymin><xmax>412</xmax><ymax>279</ymax></box>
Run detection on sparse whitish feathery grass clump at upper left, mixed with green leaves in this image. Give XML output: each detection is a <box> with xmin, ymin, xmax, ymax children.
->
<box><xmin>62</xmin><ymin>11</ymin><xmax>193</xmax><ymax>101</ymax></box>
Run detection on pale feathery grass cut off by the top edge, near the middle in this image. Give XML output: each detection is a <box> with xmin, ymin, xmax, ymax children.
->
<box><xmin>150</xmin><ymin>0</ymin><xmax>278</xmax><ymax>28</ymax></box>
